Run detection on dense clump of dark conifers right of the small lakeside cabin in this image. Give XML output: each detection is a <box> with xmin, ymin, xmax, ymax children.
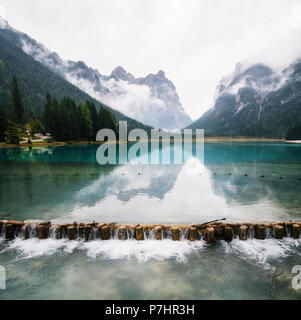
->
<box><xmin>44</xmin><ymin>94</ymin><xmax>117</xmax><ymax>141</ymax></box>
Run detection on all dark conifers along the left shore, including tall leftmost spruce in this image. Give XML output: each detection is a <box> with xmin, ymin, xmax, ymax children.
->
<box><xmin>0</xmin><ymin>77</ymin><xmax>117</xmax><ymax>144</ymax></box>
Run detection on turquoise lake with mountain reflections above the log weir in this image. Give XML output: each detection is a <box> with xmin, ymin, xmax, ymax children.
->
<box><xmin>0</xmin><ymin>143</ymin><xmax>301</xmax><ymax>223</ymax></box>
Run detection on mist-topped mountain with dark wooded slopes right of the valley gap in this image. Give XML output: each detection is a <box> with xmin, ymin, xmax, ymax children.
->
<box><xmin>188</xmin><ymin>59</ymin><xmax>301</xmax><ymax>138</ymax></box>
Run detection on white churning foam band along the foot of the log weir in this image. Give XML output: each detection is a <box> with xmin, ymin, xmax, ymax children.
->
<box><xmin>0</xmin><ymin>238</ymin><xmax>301</xmax><ymax>269</ymax></box>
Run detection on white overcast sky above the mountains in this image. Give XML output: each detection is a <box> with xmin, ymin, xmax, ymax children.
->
<box><xmin>0</xmin><ymin>0</ymin><xmax>301</xmax><ymax>119</ymax></box>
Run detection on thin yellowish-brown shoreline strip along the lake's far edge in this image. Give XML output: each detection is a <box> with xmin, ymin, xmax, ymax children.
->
<box><xmin>0</xmin><ymin>137</ymin><xmax>288</xmax><ymax>148</ymax></box>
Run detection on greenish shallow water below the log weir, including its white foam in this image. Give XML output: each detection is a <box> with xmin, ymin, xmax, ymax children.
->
<box><xmin>0</xmin><ymin>239</ymin><xmax>301</xmax><ymax>299</ymax></box>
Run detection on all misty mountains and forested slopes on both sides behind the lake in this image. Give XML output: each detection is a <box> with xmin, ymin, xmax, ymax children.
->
<box><xmin>0</xmin><ymin>15</ymin><xmax>301</xmax><ymax>138</ymax></box>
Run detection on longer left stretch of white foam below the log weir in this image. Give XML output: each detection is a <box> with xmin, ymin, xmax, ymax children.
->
<box><xmin>0</xmin><ymin>238</ymin><xmax>206</xmax><ymax>263</ymax></box>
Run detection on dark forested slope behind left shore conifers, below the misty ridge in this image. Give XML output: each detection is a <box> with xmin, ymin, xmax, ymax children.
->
<box><xmin>0</xmin><ymin>21</ymin><xmax>151</xmax><ymax>131</ymax></box>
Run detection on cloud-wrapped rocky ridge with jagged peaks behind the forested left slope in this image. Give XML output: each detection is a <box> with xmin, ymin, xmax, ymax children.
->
<box><xmin>0</xmin><ymin>19</ymin><xmax>192</xmax><ymax>130</ymax></box>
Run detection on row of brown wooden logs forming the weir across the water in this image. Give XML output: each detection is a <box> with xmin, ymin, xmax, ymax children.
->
<box><xmin>0</xmin><ymin>220</ymin><xmax>301</xmax><ymax>243</ymax></box>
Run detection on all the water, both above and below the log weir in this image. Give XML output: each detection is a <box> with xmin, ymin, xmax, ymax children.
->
<box><xmin>0</xmin><ymin>143</ymin><xmax>301</xmax><ymax>299</ymax></box>
